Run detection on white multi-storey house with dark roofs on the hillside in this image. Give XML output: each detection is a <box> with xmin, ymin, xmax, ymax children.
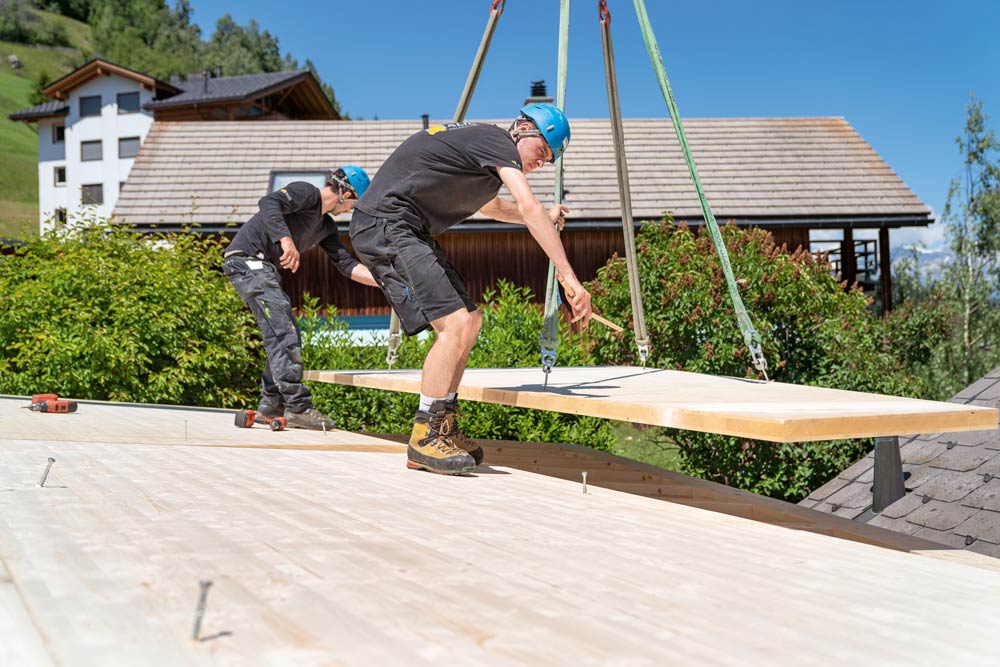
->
<box><xmin>10</xmin><ymin>58</ymin><xmax>339</xmax><ymax>232</ymax></box>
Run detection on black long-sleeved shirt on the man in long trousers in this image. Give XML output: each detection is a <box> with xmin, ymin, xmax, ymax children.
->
<box><xmin>226</xmin><ymin>181</ymin><xmax>358</xmax><ymax>277</ymax></box>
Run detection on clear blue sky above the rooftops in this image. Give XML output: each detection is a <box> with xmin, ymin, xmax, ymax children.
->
<box><xmin>192</xmin><ymin>0</ymin><xmax>1000</xmax><ymax>246</ymax></box>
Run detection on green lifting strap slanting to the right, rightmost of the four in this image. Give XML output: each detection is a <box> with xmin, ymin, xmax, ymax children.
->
<box><xmin>634</xmin><ymin>0</ymin><xmax>767</xmax><ymax>380</ymax></box>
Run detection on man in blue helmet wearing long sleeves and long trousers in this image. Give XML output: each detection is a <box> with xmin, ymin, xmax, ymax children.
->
<box><xmin>222</xmin><ymin>165</ymin><xmax>377</xmax><ymax>430</ymax></box>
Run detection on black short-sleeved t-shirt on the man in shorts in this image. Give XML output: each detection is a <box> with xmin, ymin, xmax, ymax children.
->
<box><xmin>355</xmin><ymin>123</ymin><xmax>522</xmax><ymax>234</ymax></box>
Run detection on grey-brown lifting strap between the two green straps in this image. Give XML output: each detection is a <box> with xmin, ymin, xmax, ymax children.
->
<box><xmin>600</xmin><ymin>0</ymin><xmax>649</xmax><ymax>366</ymax></box>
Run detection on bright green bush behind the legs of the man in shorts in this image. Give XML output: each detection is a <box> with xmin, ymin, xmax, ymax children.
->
<box><xmin>302</xmin><ymin>281</ymin><xmax>613</xmax><ymax>449</ymax></box>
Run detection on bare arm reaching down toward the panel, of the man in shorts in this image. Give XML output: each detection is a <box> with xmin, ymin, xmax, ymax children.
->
<box><xmin>496</xmin><ymin>167</ymin><xmax>591</xmax><ymax>326</ymax></box>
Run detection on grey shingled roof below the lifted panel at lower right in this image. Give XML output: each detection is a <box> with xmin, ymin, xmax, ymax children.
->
<box><xmin>800</xmin><ymin>368</ymin><xmax>1000</xmax><ymax>557</ymax></box>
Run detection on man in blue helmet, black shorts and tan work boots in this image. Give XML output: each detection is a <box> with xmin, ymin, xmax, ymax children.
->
<box><xmin>351</xmin><ymin>104</ymin><xmax>591</xmax><ymax>475</ymax></box>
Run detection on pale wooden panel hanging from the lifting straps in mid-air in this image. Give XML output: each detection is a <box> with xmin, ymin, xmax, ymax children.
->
<box><xmin>305</xmin><ymin>366</ymin><xmax>997</xmax><ymax>442</ymax></box>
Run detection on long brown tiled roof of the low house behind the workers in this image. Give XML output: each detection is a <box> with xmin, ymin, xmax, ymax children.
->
<box><xmin>115</xmin><ymin>118</ymin><xmax>933</xmax><ymax>234</ymax></box>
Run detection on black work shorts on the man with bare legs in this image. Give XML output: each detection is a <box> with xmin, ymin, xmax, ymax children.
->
<box><xmin>351</xmin><ymin>209</ymin><xmax>477</xmax><ymax>336</ymax></box>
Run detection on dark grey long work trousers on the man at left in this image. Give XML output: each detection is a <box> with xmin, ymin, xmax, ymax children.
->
<box><xmin>222</xmin><ymin>255</ymin><xmax>312</xmax><ymax>412</ymax></box>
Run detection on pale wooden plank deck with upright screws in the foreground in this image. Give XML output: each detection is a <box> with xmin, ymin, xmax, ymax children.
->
<box><xmin>0</xmin><ymin>398</ymin><xmax>1000</xmax><ymax>667</ymax></box>
